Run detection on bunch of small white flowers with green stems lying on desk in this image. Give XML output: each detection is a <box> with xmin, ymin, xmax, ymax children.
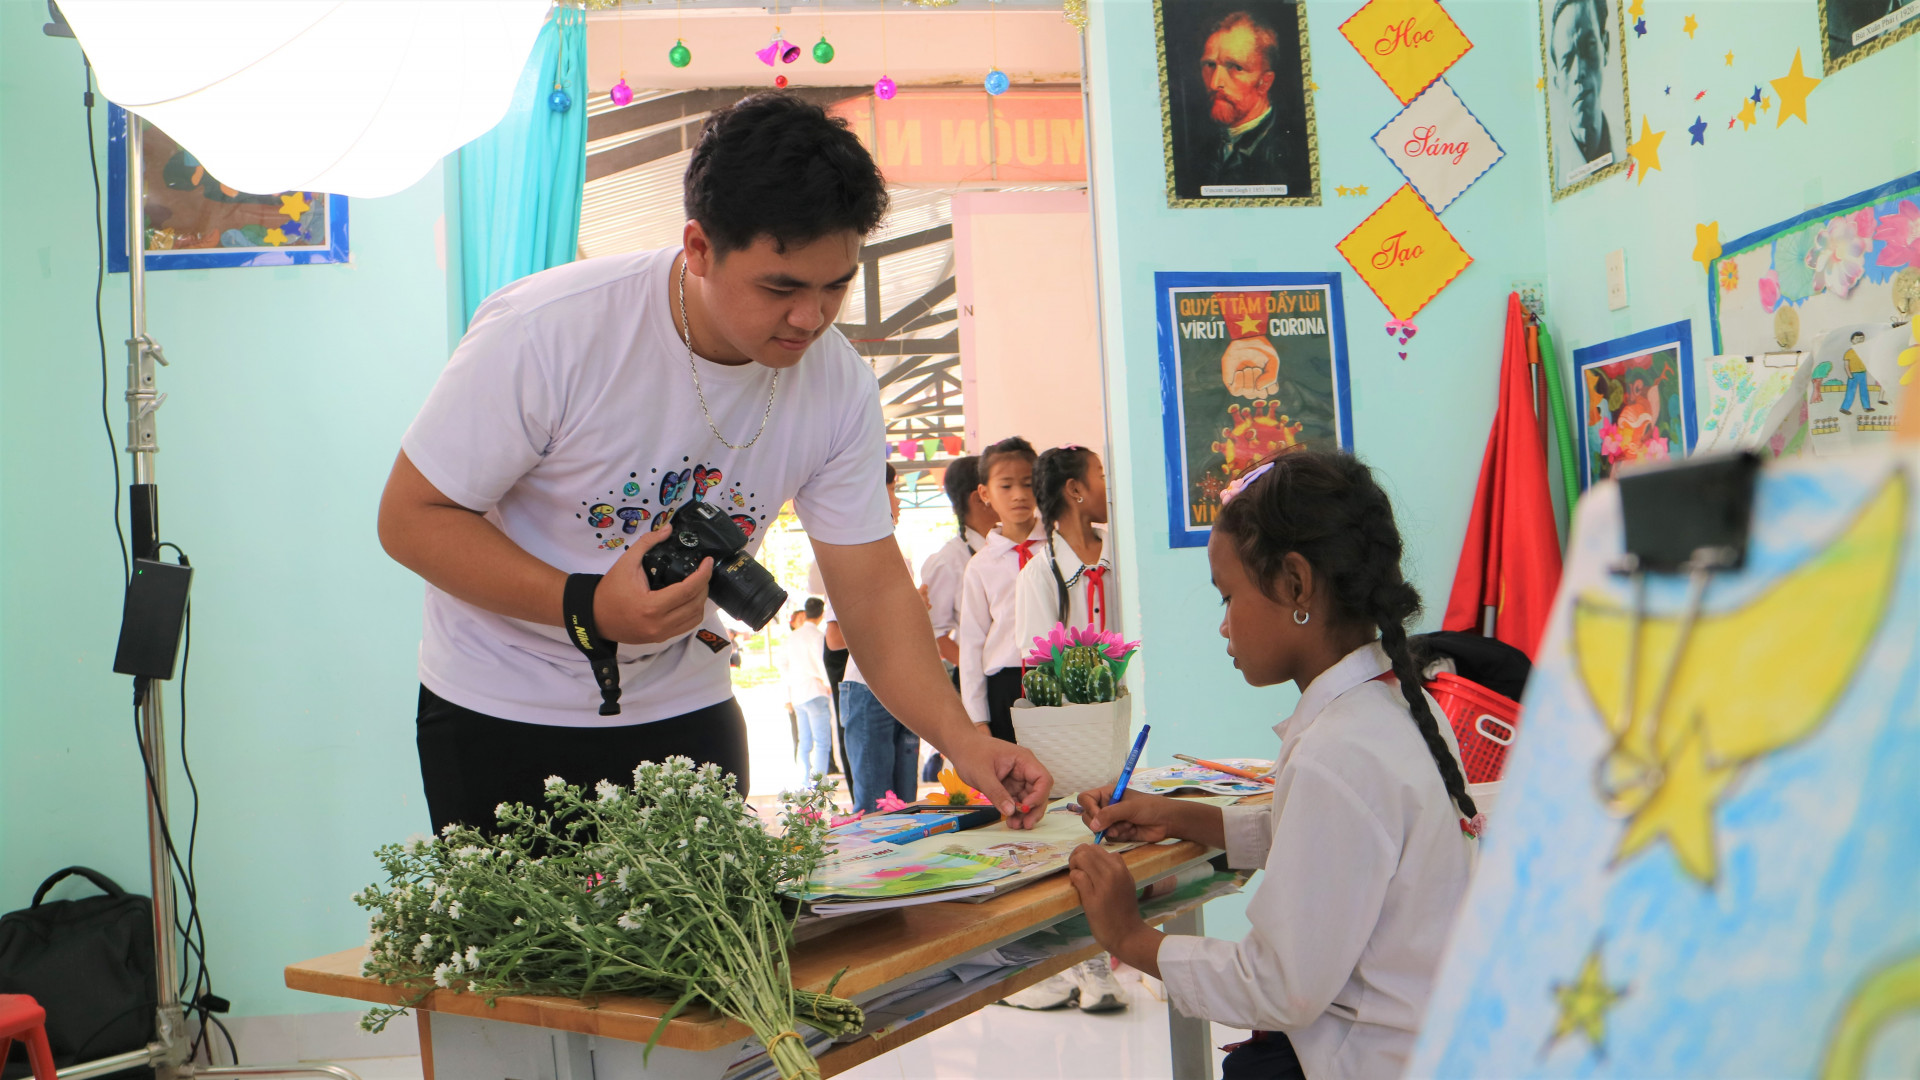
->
<box><xmin>353</xmin><ymin>757</ymin><xmax>864</xmax><ymax>1080</ymax></box>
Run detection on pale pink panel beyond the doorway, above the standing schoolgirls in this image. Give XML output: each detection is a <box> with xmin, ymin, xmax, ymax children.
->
<box><xmin>954</xmin><ymin>190</ymin><xmax>1106</xmax><ymax>454</ymax></box>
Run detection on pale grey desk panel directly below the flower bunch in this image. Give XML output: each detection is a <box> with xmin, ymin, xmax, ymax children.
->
<box><xmin>432</xmin><ymin>1013</ymin><xmax>747</xmax><ymax>1080</ymax></box>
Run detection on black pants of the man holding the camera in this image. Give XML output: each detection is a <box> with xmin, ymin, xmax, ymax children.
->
<box><xmin>415</xmin><ymin>686</ymin><xmax>747</xmax><ymax>834</ymax></box>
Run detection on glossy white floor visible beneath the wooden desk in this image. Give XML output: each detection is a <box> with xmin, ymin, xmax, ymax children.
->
<box><xmin>314</xmin><ymin>980</ymin><xmax>1246</xmax><ymax>1080</ymax></box>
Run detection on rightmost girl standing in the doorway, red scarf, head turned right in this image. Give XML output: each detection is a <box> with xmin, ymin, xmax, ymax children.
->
<box><xmin>1014</xmin><ymin>446</ymin><xmax>1119</xmax><ymax>651</ymax></box>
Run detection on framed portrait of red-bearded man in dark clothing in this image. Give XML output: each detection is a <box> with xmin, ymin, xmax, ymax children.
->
<box><xmin>1154</xmin><ymin>0</ymin><xmax>1321</xmax><ymax>208</ymax></box>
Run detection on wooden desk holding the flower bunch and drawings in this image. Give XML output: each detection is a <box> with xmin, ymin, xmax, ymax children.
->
<box><xmin>286</xmin><ymin>842</ymin><xmax>1215</xmax><ymax>1080</ymax></box>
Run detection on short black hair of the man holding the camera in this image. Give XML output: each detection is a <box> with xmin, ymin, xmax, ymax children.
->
<box><xmin>685</xmin><ymin>92</ymin><xmax>887</xmax><ymax>256</ymax></box>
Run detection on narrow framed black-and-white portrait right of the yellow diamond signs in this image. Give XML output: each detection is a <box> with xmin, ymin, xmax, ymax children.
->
<box><xmin>1540</xmin><ymin>0</ymin><xmax>1634</xmax><ymax>198</ymax></box>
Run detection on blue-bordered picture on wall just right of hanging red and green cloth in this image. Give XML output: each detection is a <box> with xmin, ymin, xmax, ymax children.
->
<box><xmin>1572</xmin><ymin>321</ymin><xmax>1699</xmax><ymax>488</ymax></box>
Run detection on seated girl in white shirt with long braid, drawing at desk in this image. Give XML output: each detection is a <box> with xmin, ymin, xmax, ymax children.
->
<box><xmin>1071</xmin><ymin>450</ymin><xmax>1482</xmax><ymax>1080</ymax></box>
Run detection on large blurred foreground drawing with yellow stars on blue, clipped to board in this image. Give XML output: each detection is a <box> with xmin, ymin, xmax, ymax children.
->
<box><xmin>1407</xmin><ymin>450</ymin><xmax>1920</xmax><ymax>1080</ymax></box>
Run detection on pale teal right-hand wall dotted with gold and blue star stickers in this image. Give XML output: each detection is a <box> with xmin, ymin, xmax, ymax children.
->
<box><xmin>1546</xmin><ymin>0</ymin><xmax>1920</xmax><ymax>359</ymax></box>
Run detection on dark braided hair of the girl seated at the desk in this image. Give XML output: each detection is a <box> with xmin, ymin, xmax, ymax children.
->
<box><xmin>1213</xmin><ymin>450</ymin><xmax>1478</xmax><ymax>817</ymax></box>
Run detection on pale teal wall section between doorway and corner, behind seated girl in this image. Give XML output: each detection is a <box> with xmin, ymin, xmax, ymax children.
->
<box><xmin>1087</xmin><ymin>0</ymin><xmax>1546</xmax><ymax>761</ymax></box>
